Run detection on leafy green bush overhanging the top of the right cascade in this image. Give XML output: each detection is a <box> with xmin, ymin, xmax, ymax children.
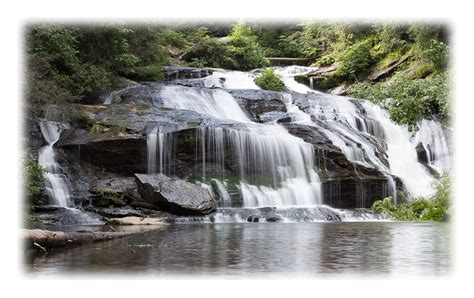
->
<box><xmin>348</xmin><ymin>72</ymin><xmax>451</xmax><ymax>129</ymax></box>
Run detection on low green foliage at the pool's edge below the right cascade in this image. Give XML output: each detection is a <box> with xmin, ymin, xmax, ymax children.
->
<box><xmin>372</xmin><ymin>174</ymin><xmax>452</xmax><ymax>221</ymax></box>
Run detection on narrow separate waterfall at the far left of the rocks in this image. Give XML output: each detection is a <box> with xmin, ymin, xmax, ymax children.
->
<box><xmin>38</xmin><ymin>121</ymin><xmax>70</xmax><ymax>207</ymax></box>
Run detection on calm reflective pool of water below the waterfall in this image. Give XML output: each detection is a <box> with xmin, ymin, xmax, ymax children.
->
<box><xmin>25</xmin><ymin>222</ymin><xmax>451</xmax><ymax>277</ymax></box>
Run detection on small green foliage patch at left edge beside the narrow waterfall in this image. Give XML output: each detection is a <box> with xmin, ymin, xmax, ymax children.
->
<box><xmin>23</xmin><ymin>157</ymin><xmax>48</xmax><ymax>205</ymax></box>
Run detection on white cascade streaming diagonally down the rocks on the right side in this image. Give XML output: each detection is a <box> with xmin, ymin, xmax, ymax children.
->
<box><xmin>277</xmin><ymin>66</ymin><xmax>442</xmax><ymax>200</ymax></box>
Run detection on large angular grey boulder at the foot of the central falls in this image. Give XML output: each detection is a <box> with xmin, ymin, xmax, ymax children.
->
<box><xmin>135</xmin><ymin>174</ymin><xmax>217</xmax><ymax>215</ymax></box>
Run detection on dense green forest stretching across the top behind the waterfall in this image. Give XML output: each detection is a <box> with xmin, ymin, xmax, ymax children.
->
<box><xmin>26</xmin><ymin>22</ymin><xmax>450</xmax><ymax>126</ymax></box>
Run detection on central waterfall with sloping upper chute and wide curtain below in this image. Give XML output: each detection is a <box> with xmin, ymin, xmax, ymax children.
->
<box><xmin>160</xmin><ymin>86</ymin><xmax>322</xmax><ymax>207</ymax></box>
